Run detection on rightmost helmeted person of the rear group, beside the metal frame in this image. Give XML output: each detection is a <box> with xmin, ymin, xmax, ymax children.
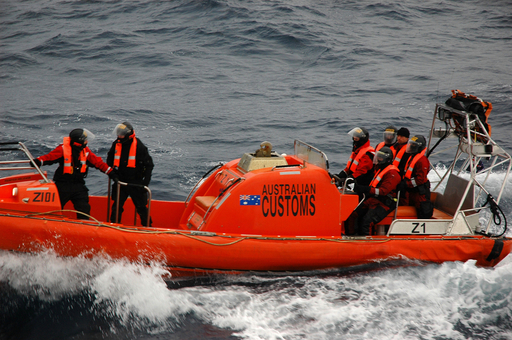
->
<box><xmin>402</xmin><ymin>135</ymin><xmax>434</xmax><ymax>218</ymax></box>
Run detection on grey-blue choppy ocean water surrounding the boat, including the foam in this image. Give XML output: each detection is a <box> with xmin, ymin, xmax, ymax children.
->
<box><xmin>0</xmin><ymin>0</ymin><xmax>512</xmax><ymax>340</ymax></box>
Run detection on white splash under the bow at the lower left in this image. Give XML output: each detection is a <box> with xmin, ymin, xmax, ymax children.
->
<box><xmin>0</xmin><ymin>251</ymin><xmax>195</xmax><ymax>324</ymax></box>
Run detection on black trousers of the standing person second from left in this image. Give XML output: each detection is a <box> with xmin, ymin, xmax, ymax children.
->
<box><xmin>110</xmin><ymin>184</ymin><xmax>151</xmax><ymax>226</ymax></box>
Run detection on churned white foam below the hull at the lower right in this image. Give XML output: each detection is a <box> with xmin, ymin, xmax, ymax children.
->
<box><xmin>174</xmin><ymin>257</ymin><xmax>512</xmax><ymax>339</ymax></box>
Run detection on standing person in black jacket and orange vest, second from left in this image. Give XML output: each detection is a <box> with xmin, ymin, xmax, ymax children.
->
<box><xmin>107</xmin><ymin>122</ymin><xmax>154</xmax><ymax>226</ymax></box>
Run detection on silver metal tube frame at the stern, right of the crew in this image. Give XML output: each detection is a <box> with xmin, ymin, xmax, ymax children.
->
<box><xmin>418</xmin><ymin>104</ymin><xmax>512</xmax><ymax>235</ymax></box>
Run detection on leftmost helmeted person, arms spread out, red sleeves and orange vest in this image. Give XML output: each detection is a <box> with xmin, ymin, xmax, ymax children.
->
<box><xmin>34</xmin><ymin>129</ymin><xmax>117</xmax><ymax>220</ymax></box>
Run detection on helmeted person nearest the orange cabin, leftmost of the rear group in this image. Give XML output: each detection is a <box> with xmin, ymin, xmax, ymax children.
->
<box><xmin>338</xmin><ymin>127</ymin><xmax>375</xmax><ymax>185</ymax></box>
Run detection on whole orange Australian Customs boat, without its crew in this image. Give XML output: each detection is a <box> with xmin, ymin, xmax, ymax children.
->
<box><xmin>0</xmin><ymin>95</ymin><xmax>512</xmax><ymax>276</ymax></box>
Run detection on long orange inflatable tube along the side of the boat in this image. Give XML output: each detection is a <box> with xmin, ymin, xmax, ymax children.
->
<box><xmin>0</xmin><ymin>214</ymin><xmax>512</xmax><ymax>277</ymax></box>
